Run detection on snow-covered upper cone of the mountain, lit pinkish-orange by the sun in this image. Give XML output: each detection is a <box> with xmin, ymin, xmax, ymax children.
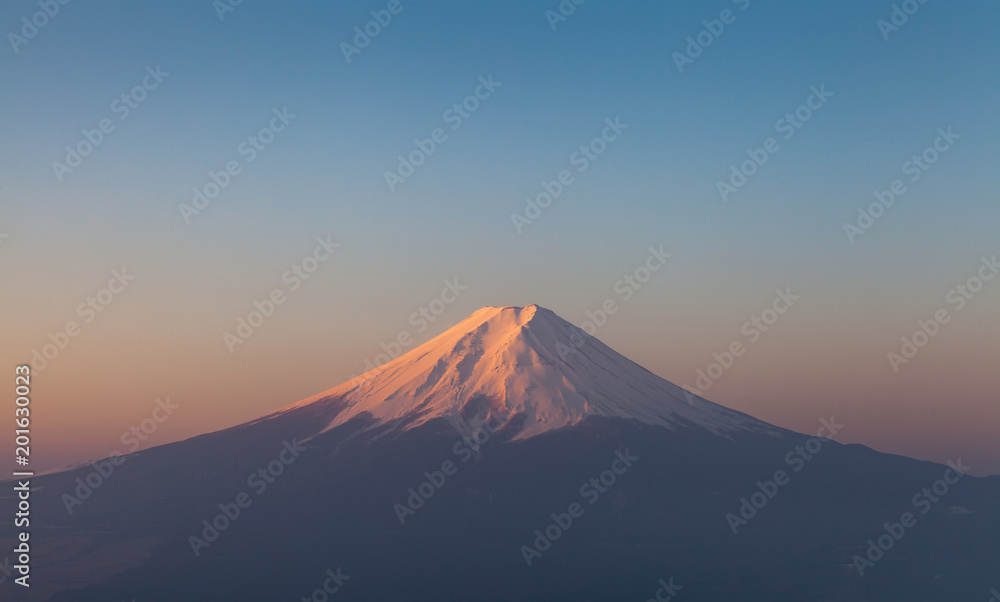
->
<box><xmin>285</xmin><ymin>305</ymin><xmax>781</xmax><ymax>438</ymax></box>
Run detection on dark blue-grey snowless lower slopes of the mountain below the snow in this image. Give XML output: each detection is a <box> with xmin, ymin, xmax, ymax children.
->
<box><xmin>0</xmin><ymin>406</ymin><xmax>1000</xmax><ymax>602</ymax></box>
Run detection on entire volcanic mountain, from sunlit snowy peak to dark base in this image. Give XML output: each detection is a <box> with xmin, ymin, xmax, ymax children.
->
<box><xmin>0</xmin><ymin>306</ymin><xmax>1000</xmax><ymax>602</ymax></box>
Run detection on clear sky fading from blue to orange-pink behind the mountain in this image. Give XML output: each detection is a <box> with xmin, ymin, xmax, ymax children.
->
<box><xmin>0</xmin><ymin>0</ymin><xmax>1000</xmax><ymax>474</ymax></box>
